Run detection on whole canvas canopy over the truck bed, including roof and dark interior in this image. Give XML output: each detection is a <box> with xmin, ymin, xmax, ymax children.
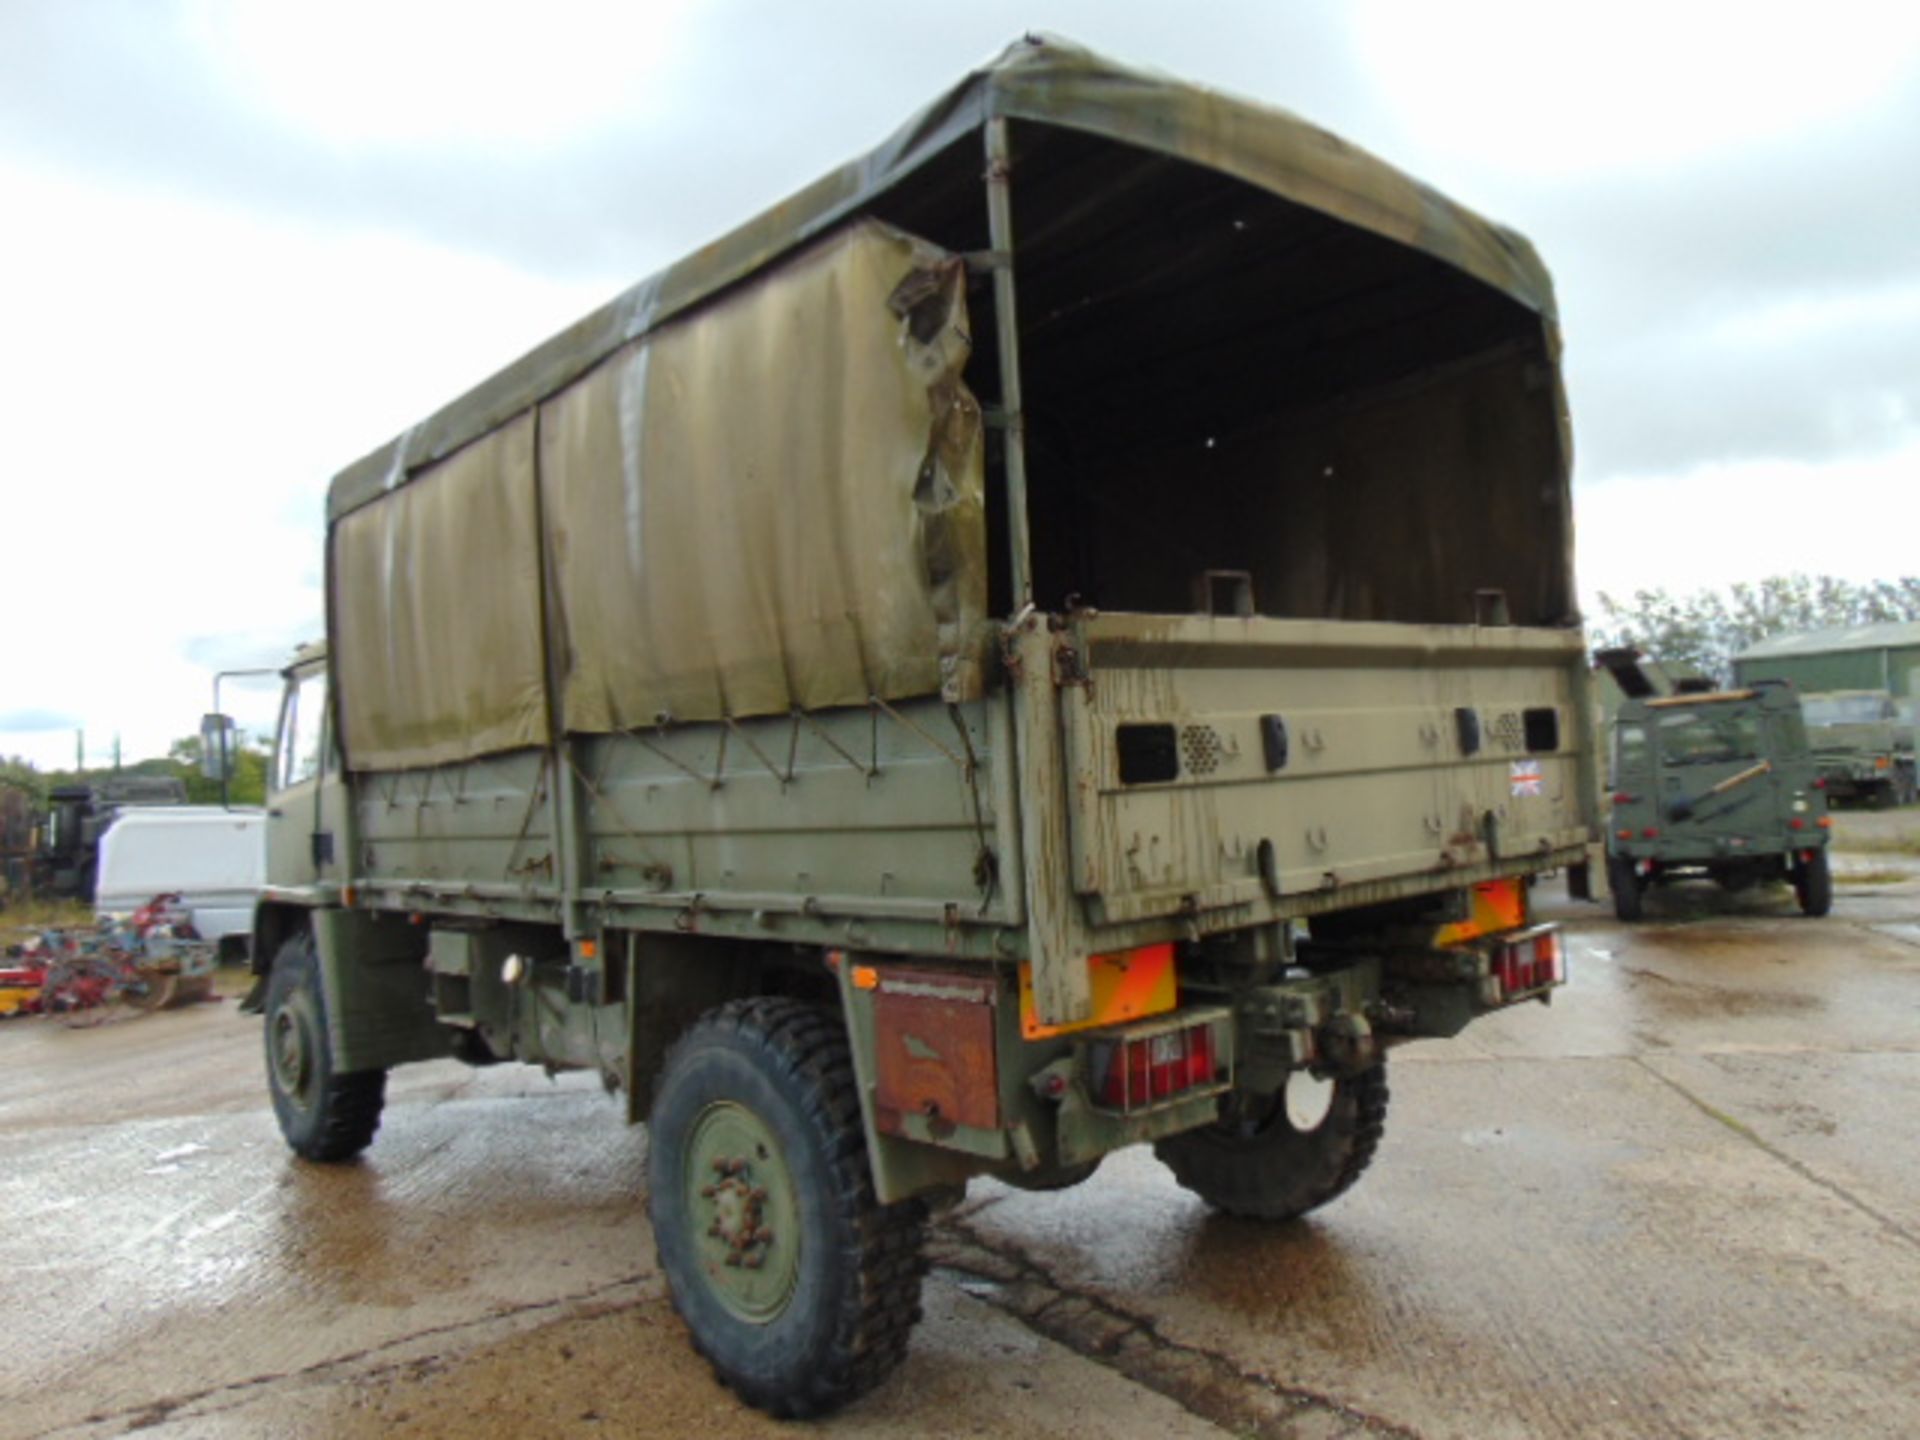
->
<box><xmin>328</xmin><ymin>40</ymin><xmax>1574</xmax><ymax>768</ymax></box>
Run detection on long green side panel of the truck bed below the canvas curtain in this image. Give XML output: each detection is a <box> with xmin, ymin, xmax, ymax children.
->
<box><xmin>353</xmin><ymin>701</ymin><xmax>1023</xmax><ymax>948</ymax></box>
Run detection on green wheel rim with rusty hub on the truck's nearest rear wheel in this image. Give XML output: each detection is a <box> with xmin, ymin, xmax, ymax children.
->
<box><xmin>685</xmin><ymin>1100</ymin><xmax>801</xmax><ymax>1325</ymax></box>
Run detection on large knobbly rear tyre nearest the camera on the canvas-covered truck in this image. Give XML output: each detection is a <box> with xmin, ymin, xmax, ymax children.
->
<box><xmin>647</xmin><ymin>998</ymin><xmax>927</xmax><ymax>1417</ymax></box>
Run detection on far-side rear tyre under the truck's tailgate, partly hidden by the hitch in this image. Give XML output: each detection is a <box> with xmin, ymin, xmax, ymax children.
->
<box><xmin>1154</xmin><ymin>1060</ymin><xmax>1386</xmax><ymax>1219</ymax></box>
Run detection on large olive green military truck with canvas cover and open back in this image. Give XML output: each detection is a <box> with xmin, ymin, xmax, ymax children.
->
<box><xmin>228</xmin><ymin>40</ymin><xmax>1601</xmax><ymax>1415</ymax></box>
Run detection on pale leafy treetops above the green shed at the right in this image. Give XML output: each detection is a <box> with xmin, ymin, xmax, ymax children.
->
<box><xmin>1590</xmin><ymin>574</ymin><xmax>1920</xmax><ymax>684</ymax></box>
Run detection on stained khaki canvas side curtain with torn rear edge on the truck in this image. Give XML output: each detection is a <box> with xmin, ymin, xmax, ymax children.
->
<box><xmin>332</xmin><ymin>221</ymin><xmax>985</xmax><ymax>770</ymax></box>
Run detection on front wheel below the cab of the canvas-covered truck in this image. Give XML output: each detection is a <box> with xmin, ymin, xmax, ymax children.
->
<box><xmin>261</xmin><ymin>931</ymin><xmax>386</xmax><ymax>1164</ymax></box>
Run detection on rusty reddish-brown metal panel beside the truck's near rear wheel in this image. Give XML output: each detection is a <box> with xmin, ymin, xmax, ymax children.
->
<box><xmin>874</xmin><ymin>968</ymin><xmax>1000</xmax><ymax>1135</ymax></box>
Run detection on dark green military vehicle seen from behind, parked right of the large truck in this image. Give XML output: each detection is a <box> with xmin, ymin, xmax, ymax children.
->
<box><xmin>1597</xmin><ymin>649</ymin><xmax>1834</xmax><ymax>920</ymax></box>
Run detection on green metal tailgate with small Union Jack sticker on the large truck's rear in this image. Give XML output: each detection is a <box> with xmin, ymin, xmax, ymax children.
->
<box><xmin>1062</xmin><ymin>614</ymin><xmax>1597</xmax><ymax>925</ymax></box>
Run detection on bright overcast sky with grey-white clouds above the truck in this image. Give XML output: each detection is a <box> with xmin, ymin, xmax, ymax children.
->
<box><xmin>0</xmin><ymin>0</ymin><xmax>1920</xmax><ymax>766</ymax></box>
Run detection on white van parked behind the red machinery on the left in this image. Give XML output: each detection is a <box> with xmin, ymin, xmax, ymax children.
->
<box><xmin>94</xmin><ymin>804</ymin><xmax>267</xmax><ymax>958</ymax></box>
